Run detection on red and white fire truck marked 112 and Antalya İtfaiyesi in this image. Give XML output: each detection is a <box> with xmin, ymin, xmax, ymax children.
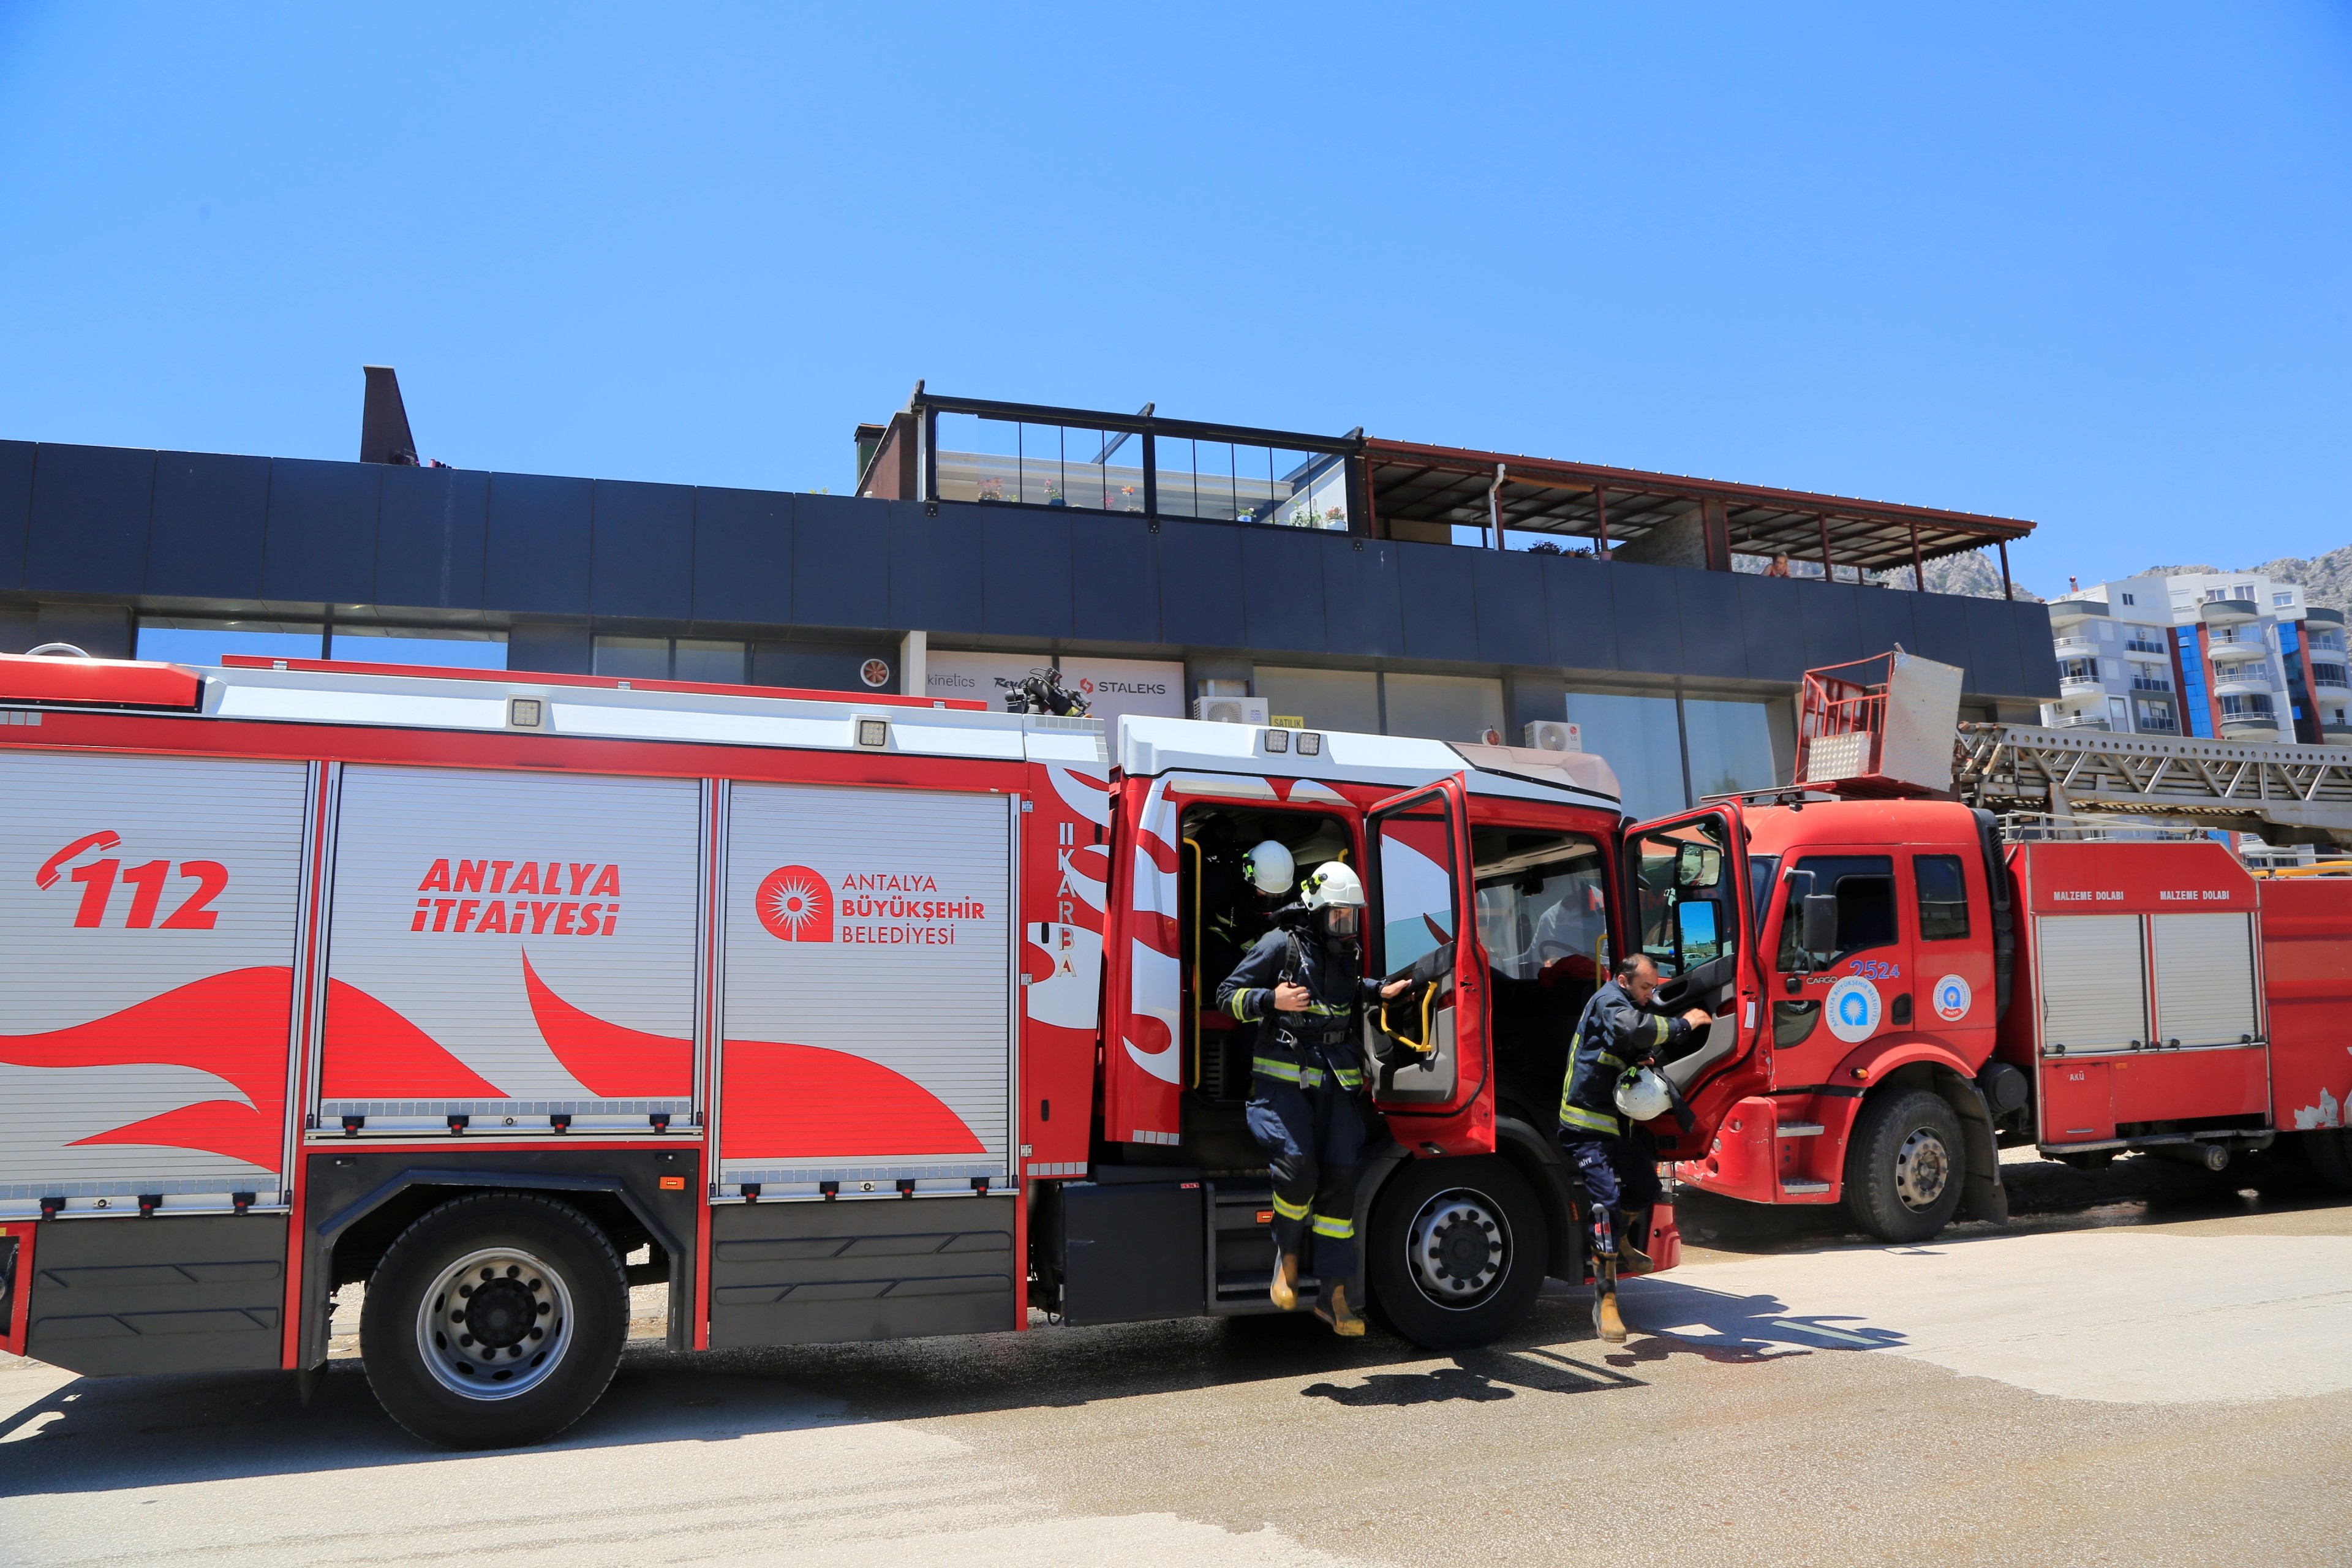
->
<box><xmin>0</xmin><ymin>656</ymin><xmax>1749</xmax><ymax>1446</ymax></box>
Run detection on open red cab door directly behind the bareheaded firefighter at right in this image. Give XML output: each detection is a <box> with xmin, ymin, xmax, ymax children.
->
<box><xmin>1621</xmin><ymin>802</ymin><xmax>1771</xmax><ymax>1159</ymax></box>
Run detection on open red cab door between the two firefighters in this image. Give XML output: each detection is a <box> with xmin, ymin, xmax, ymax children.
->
<box><xmin>1364</xmin><ymin>778</ymin><xmax>1493</xmax><ymax>1152</ymax></box>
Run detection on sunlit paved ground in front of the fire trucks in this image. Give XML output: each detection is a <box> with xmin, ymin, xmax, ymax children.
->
<box><xmin>0</xmin><ymin>1161</ymin><xmax>2352</xmax><ymax>1568</ymax></box>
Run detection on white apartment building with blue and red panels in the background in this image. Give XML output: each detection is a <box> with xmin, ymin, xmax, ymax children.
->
<box><xmin>2041</xmin><ymin>571</ymin><xmax>2352</xmax><ymax>745</ymax></box>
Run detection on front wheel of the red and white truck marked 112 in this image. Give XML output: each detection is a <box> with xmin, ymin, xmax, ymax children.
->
<box><xmin>1364</xmin><ymin>1156</ymin><xmax>1550</xmax><ymax>1349</ymax></box>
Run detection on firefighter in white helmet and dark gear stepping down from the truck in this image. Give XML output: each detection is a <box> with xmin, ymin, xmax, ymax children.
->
<box><xmin>1216</xmin><ymin>861</ymin><xmax>1411</xmax><ymax>1338</ymax></box>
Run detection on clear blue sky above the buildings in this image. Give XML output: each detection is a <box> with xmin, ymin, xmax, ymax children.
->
<box><xmin>0</xmin><ymin>0</ymin><xmax>2352</xmax><ymax>590</ymax></box>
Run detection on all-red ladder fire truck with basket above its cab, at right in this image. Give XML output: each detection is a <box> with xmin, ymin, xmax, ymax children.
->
<box><xmin>1675</xmin><ymin>651</ymin><xmax>2352</xmax><ymax>1242</ymax></box>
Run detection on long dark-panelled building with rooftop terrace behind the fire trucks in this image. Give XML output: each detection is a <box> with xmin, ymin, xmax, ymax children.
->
<box><xmin>0</xmin><ymin>385</ymin><xmax>2058</xmax><ymax>816</ymax></box>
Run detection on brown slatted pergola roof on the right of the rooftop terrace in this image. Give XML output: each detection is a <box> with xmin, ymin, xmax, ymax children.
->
<box><xmin>1364</xmin><ymin>437</ymin><xmax>2035</xmax><ymax>578</ymax></box>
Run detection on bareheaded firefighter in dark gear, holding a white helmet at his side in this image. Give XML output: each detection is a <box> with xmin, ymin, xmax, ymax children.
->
<box><xmin>1559</xmin><ymin>952</ymin><xmax>1710</xmax><ymax>1344</ymax></box>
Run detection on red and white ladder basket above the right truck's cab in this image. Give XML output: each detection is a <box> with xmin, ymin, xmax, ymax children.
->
<box><xmin>1797</xmin><ymin>644</ymin><xmax>1959</xmax><ymax>794</ymax></box>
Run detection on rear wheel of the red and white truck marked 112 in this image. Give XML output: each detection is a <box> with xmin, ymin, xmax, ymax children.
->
<box><xmin>360</xmin><ymin>1192</ymin><xmax>628</xmax><ymax>1448</ymax></box>
